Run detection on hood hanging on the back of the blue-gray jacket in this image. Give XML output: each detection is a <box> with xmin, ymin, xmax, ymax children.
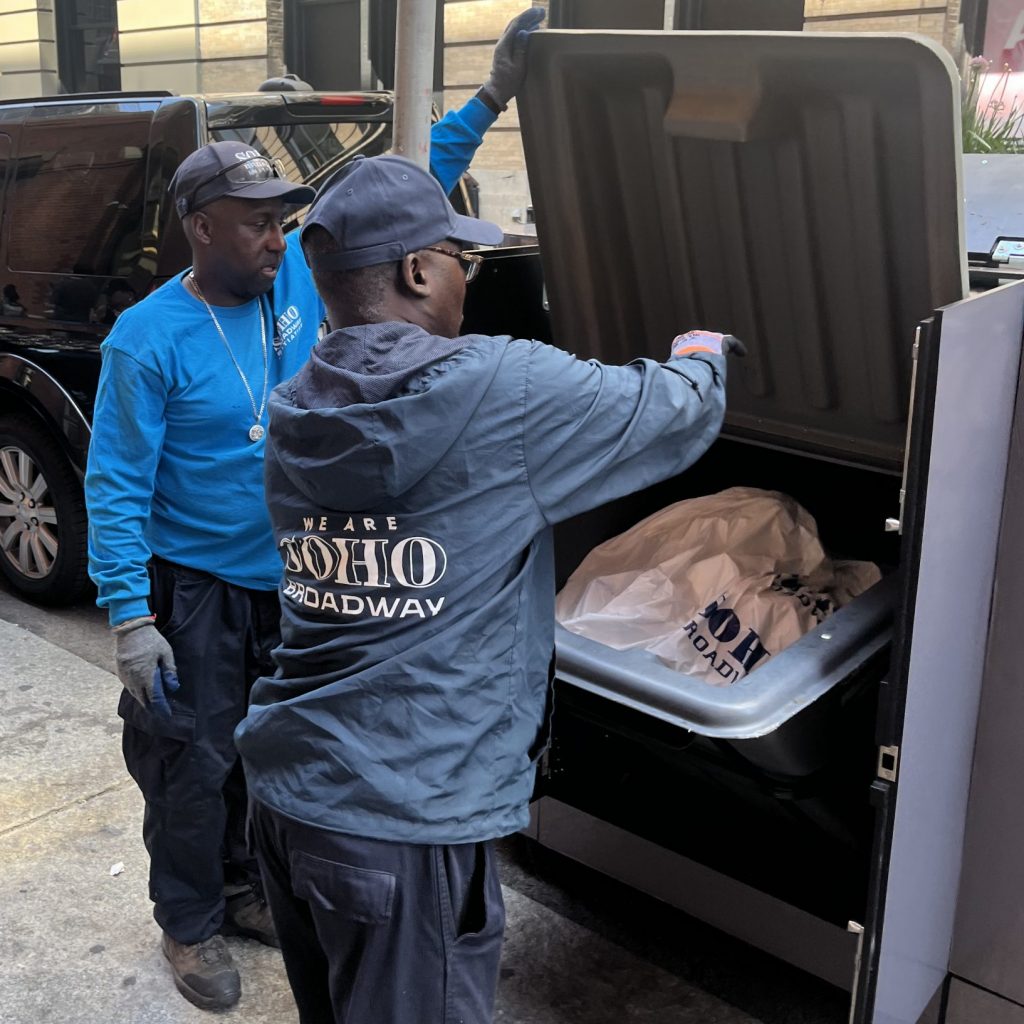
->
<box><xmin>267</xmin><ymin>324</ymin><xmax>509</xmax><ymax>510</ymax></box>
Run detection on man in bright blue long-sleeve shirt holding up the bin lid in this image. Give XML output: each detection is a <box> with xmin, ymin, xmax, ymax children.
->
<box><xmin>86</xmin><ymin>9</ymin><xmax>543</xmax><ymax>1009</ymax></box>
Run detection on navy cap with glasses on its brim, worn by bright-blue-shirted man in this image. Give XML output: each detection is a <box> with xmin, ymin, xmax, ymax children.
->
<box><xmin>168</xmin><ymin>142</ymin><xmax>316</xmax><ymax>217</ymax></box>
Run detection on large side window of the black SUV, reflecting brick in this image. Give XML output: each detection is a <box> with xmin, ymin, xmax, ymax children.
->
<box><xmin>7</xmin><ymin>103</ymin><xmax>153</xmax><ymax>282</ymax></box>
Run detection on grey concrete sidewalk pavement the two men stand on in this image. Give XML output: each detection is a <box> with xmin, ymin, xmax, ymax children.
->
<box><xmin>0</xmin><ymin>622</ymin><xmax>758</xmax><ymax>1024</ymax></box>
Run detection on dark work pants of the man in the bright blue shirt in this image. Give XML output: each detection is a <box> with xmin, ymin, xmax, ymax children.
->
<box><xmin>118</xmin><ymin>558</ymin><xmax>281</xmax><ymax>943</ymax></box>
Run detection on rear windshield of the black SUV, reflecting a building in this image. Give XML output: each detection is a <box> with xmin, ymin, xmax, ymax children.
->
<box><xmin>210</xmin><ymin>121</ymin><xmax>391</xmax><ymax>229</ymax></box>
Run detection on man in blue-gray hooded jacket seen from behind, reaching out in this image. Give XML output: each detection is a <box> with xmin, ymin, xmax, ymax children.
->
<box><xmin>236</xmin><ymin>157</ymin><xmax>738</xmax><ymax>1024</ymax></box>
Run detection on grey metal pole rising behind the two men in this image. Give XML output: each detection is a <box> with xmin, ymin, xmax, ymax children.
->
<box><xmin>391</xmin><ymin>0</ymin><xmax>437</xmax><ymax>170</ymax></box>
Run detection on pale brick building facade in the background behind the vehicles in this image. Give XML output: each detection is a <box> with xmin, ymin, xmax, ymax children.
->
<box><xmin>0</xmin><ymin>0</ymin><xmax>987</xmax><ymax>236</ymax></box>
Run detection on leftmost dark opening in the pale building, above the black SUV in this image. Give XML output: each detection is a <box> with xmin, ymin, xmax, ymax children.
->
<box><xmin>54</xmin><ymin>0</ymin><xmax>121</xmax><ymax>92</ymax></box>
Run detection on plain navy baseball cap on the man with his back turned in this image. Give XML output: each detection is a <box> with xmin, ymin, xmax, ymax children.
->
<box><xmin>302</xmin><ymin>156</ymin><xmax>505</xmax><ymax>270</ymax></box>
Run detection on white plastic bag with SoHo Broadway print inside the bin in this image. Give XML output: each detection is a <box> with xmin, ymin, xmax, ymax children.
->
<box><xmin>555</xmin><ymin>487</ymin><xmax>881</xmax><ymax>686</ymax></box>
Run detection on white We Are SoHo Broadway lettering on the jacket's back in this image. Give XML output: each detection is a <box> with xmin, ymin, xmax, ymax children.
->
<box><xmin>279</xmin><ymin>516</ymin><xmax>447</xmax><ymax>618</ymax></box>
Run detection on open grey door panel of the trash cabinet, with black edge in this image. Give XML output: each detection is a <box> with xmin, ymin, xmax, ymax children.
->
<box><xmin>856</xmin><ymin>283</ymin><xmax>1024</xmax><ymax>1024</ymax></box>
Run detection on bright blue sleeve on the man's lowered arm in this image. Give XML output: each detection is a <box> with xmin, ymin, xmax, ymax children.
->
<box><xmin>85</xmin><ymin>346</ymin><xmax>166</xmax><ymax>626</ymax></box>
